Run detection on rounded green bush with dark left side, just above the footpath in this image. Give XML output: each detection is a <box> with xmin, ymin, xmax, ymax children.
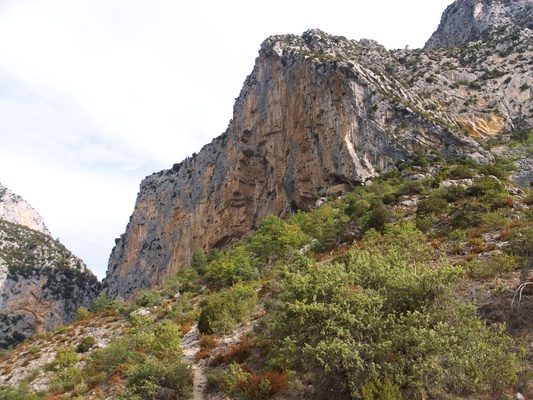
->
<box><xmin>198</xmin><ymin>283</ymin><xmax>257</xmax><ymax>335</ymax></box>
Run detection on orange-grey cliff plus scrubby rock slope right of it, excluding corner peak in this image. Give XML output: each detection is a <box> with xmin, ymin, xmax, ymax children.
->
<box><xmin>104</xmin><ymin>2</ymin><xmax>533</xmax><ymax>298</ymax></box>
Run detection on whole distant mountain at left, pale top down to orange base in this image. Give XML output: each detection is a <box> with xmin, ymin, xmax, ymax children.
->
<box><xmin>0</xmin><ymin>187</ymin><xmax>100</xmax><ymax>347</ymax></box>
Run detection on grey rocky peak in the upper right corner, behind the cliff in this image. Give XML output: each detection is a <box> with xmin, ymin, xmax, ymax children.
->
<box><xmin>425</xmin><ymin>0</ymin><xmax>533</xmax><ymax>48</ymax></box>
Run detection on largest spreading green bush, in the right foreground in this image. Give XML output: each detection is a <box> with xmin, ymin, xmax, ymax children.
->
<box><xmin>267</xmin><ymin>223</ymin><xmax>517</xmax><ymax>399</ymax></box>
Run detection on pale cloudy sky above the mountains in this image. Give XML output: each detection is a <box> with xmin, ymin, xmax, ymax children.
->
<box><xmin>0</xmin><ymin>0</ymin><xmax>452</xmax><ymax>279</ymax></box>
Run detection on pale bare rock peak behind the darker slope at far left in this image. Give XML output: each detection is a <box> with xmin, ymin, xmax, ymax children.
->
<box><xmin>0</xmin><ymin>184</ymin><xmax>51</xmax><ymax>235</ymax></box>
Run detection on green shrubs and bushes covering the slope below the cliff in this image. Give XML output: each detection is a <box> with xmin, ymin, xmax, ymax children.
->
<box><xmin>0</xmin><ymin>152</ymin><xmax>533</xmax><ymax>400</ymax></box>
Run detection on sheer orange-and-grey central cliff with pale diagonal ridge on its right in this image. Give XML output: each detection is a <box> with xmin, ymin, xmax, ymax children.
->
<box><xmin>104</xmin><ymin>30</ymin><xmax>498</xmax><ymax>298</ymax></box>
